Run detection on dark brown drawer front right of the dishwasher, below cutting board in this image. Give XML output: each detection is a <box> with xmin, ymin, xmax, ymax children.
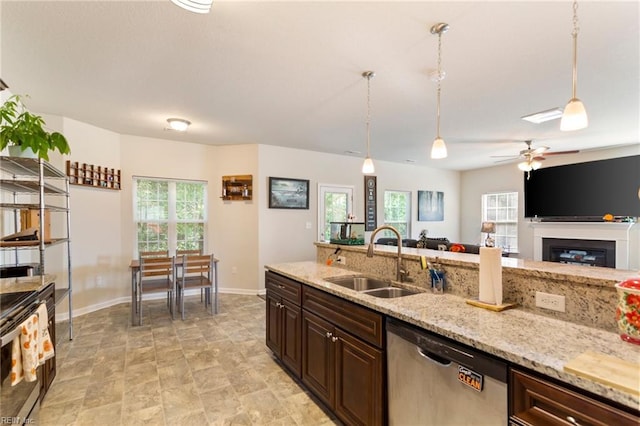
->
<box><xmin>509</xmin><ymin>370</ymin><xmax>640</xmax><ymax>426</ymax></box>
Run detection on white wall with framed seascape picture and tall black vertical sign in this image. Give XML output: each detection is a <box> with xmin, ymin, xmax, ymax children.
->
<box><xmin>254</xmin><ymin>145</ymin><xmax>460</xmax><ymax>289</ymax></box>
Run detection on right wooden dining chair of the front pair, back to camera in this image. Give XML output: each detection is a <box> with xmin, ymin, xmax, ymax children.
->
<box><xmin>176</xmin><ymin>254</ymin><xmax>218</xmax><ymax>320</ymax></box>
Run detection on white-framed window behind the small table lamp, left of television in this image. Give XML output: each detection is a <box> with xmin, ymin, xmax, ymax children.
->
<box><xmin>482</xmin><ymin>192</ymin><xmax>518</xmax><ymax>253</ymax></box>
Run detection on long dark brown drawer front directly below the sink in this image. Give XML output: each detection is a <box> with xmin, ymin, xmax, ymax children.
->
<box><xmin>302</xmin><ymin>286</ymin><xmax>384</xmax><ymax>348</ymax></box>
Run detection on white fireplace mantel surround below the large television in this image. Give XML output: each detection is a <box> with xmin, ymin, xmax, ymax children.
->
<box><xmin>530</xmin><ymin>222</ymin><xmax>640</xmax><ymax>269</ymax></box>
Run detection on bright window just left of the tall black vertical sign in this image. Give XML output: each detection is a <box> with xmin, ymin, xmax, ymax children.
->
<box><xmin>318</xmin><ymin>184</ymin><xmax>353</xmax><ymax>241</ymax></box>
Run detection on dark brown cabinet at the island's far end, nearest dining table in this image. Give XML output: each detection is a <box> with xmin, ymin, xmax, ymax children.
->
<box><xmin>265</xmin><ymin>273</ymin><xmax>302</xmax><ymax>377</ymax></box>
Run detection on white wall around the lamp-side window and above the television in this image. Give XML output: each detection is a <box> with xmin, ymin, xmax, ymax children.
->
<box><xmin>460</xmin><ymin>144</ymin><xmax>640</xmax><ymax>259</ymax></box>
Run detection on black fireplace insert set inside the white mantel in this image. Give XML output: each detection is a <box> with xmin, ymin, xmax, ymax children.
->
<box><xmin>542</xmin><ymin>238</ymin><xmax>616</xmax><ymax>268</ymax></box>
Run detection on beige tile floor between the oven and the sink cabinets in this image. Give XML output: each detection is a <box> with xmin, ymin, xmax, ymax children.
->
<box><xmin>39</xmin><ymin>294</ymin><xmax>339</xmax><ymax>426</ymax></box>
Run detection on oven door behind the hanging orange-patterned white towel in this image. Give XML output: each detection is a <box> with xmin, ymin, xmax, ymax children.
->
<box><xmin>0</xmin><ymin>331</ymin><xmax>42</xmax><ymax>424</ymax></box>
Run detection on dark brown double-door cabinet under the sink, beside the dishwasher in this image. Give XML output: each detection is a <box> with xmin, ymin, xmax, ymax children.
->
<box><xmin>302</xmin><ymin>286</ymin><xmax>386</xmax><ymax>425</ymax></box>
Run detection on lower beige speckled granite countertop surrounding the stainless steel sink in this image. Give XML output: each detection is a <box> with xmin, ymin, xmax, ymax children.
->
<box><xmin>265</xmin><ymin>262</ymin><xmax>640</xmax><ymax>410</ymax></box>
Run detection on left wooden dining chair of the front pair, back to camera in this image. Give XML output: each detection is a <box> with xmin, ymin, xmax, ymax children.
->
<box><xmin>136</xmin><ymin>256</ymin><xmax>176</xmax><ymax>325</ymax></box>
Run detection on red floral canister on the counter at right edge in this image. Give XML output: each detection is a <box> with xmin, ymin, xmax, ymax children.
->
<box><xmin>616</xmin><ymin>278</ymin><xmax>640</xmax><ymax>345</ymax></box>
